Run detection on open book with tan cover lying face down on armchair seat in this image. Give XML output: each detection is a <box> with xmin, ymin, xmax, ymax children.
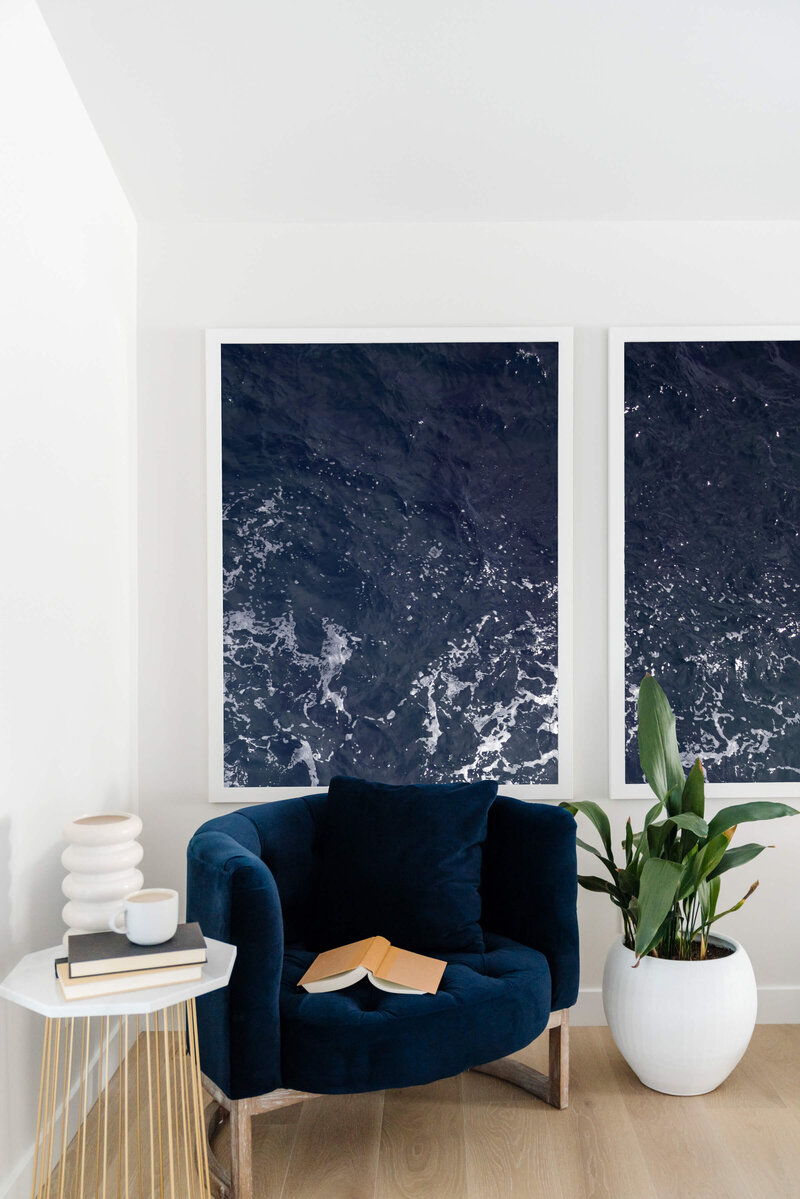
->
<box><xmin>297</xmin><ymin>936</ymin><xmax>447</xmax><ymax>995</ymax></box>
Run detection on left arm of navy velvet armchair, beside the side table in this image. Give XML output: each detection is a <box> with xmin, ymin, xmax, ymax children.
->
<box><xmin>186</xmin><ymin>813</ymin><xmax>283</xmax><ymax>1099</ymax></box>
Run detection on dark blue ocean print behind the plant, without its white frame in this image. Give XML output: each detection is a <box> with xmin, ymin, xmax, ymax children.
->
<box><xmin>625</xmin><ymin>341</ymin><xmax>800</xmax><ymax>784</ymax></box>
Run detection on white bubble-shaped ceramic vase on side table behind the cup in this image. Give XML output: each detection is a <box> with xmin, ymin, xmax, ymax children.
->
<box><xmin>61</xmin><ymin>812</ymin><xmax>144</xmax><ymax>939</ymax></box>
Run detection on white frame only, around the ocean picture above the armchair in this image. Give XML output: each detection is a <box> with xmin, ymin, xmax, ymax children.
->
<box><xmin>205</xmin><ymin>326</ymin><xmax>573</xmax><ymax>806</ymax></box>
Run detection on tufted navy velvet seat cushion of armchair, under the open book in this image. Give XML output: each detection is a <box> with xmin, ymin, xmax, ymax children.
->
<box><xmin>281</xmin><ymin>933</ymin><xmax>551</xmax><ymax>1095</ymax></box>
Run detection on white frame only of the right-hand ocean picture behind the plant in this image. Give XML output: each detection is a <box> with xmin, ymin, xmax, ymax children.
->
<box><xmin>608</xmin><ymin>325</ymin><xmax>800</xmax><ymax>801</ymax></box>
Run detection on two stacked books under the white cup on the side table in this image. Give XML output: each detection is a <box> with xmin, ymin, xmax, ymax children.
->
<box><xmin>55</xmin><ymin>923</ymin><xmax>207</xmax><ymax>999</ymax></box>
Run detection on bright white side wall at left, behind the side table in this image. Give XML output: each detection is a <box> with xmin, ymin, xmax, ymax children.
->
<box><xmin>0</xmin><ymin>0</ymin><xmax>137</xmax><ymax>1195</ymax></box>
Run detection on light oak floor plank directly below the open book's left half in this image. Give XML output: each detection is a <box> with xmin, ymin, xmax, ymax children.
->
<box><xmin>281</xmin><ymin>1091</ymin><xmax>384</xmax><ymax>1199</ymax></box>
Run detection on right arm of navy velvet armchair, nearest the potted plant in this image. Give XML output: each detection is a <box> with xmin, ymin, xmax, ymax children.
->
<box><xmin>481</xmin><ymin>795</ymin><xmax>579</xmax><ymax>1012</ymax></box>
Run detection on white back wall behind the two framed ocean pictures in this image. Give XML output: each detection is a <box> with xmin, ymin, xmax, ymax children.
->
<box><xmin>139</xmin><ymin>222</ymin><xmax>800</xmax><ymax>1023</ymax></box>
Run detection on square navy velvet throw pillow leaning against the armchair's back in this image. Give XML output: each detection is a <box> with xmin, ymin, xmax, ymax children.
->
<box><xmin>318</xmin><ymin>776</ymin><xmax>498</xmax><ymax>953</ymax></box>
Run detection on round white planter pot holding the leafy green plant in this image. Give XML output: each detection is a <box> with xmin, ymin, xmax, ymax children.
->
<box><xmin>603</xmin><ymin>936</ymin><xmax>758</xmax><ymax>1095</ymax></box>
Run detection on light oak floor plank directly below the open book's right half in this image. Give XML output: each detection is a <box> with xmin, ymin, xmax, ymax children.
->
<box><xmin>377</xmin><ymin>1077</ymin><xmax>467</xmax><ymax>1199</ymax></box>
